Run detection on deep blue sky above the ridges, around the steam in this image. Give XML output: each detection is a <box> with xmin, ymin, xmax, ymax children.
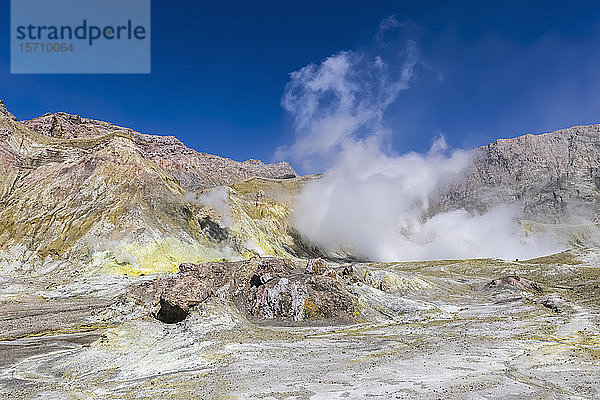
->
<box><xmin>0</xmin><ymin>0</ymin><xmax>600</xmax><ymax>172</ymax></box>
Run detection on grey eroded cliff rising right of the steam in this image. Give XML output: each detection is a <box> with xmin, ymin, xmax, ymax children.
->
<box><xmin>429</xmin><ymin>125</ymin><xmax>600</xmax><ymax>223</ymax></box>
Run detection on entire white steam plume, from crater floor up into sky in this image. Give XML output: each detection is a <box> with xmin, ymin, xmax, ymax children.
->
<box><xmin>279</xmin><ymin>19</ymin><xmax>559</xmax><ymax>261</ymax></box>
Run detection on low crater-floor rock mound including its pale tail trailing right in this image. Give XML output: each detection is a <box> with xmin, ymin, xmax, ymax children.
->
<box><xmin>125</xmin><ymin>258</ymin><xmax>443</xmax><ymax>324</ymax></box>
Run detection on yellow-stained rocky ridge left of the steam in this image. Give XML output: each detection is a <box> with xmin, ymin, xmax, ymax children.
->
<box><xmin>0</xmin><ymin>103</ymin><xmax>312</xmax><ymax>282</ymax></box>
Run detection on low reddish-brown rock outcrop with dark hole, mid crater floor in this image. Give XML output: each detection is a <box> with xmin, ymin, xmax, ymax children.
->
<box><xmin>128</xmin><ymin>258</ymin><xmax>358</xmax><ymax>323</ymax></box>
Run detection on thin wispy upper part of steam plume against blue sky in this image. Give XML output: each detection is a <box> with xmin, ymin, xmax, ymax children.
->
<box><xmin>277</xmin><ymin>42</ymin><xmax>417</xmax><ymax>171</ymax></box>
